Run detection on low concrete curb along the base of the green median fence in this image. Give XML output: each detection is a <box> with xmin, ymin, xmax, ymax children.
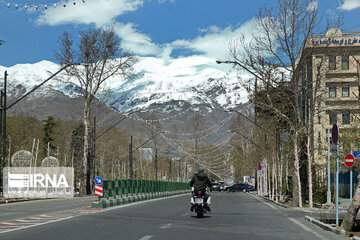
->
<box><xmin>91</xmin><ymin>190</ymin><xmax>190</xmax><ymax>208</ymax></box>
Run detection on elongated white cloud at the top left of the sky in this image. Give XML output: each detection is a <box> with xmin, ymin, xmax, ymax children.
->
<box><xmin>36</xmin><ymin>0</ymin><xmax>143</xmax><ymax>27</ymax></box>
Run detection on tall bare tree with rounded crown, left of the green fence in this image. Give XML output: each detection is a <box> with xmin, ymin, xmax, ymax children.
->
<box><xmin>55</xmin><ymin>28</ymin><xmax>137</xmax><ymax>194</ymax></box>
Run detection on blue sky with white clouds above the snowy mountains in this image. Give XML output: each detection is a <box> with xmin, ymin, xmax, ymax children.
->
<box><xmin>0</xmin><ymin>0</ymin><xmax>360</xmax><ymax>67</ymax></box>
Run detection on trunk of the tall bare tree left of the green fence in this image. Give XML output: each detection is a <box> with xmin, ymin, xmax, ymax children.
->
<box><xmin>80</xmin><ymin>99</ymin><xmax>90</xmax><ymax>194</ymax></box>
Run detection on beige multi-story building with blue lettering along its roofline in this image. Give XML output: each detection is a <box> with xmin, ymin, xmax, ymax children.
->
<box><xmin>296</xmin><ymin>29</ymin><xmax>360</xmax><ymax>181</ymax></box>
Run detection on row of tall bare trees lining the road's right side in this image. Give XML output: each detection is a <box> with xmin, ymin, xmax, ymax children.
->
<box><xmin>222</xmin><ymin>0</ymin><xmax>342</xmax><ymax>207</ymax></box>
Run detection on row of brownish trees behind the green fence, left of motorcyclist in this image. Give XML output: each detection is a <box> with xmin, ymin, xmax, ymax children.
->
<box><xmin>6</xmin><ymin>113</ymin><xmax>194</xmax><ymax>185</ymax></box>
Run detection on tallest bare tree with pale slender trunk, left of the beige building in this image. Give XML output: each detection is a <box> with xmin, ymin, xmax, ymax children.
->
<box><xmin>226</xmin><ymin>0</ymin><xmax>318</xmax><ymax>207</ymax></box>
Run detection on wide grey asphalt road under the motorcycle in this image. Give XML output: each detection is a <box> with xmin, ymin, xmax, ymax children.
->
<box><xmin>0</xmin><ymin>192</ymin><xmax>346</xmax><ymax>240</ymax></box>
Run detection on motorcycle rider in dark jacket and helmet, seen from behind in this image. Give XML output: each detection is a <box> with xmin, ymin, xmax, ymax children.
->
<box><xmin>190</xmin><ymin>167</ymin><xmax>211</xmax><ymax>212</ymax></box>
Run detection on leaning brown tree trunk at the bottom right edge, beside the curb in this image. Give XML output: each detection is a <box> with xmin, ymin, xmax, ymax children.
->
<box><xmin>341</xmin><ymin>175</ymin><xmax>360</xmax><ymax>231</ymax></box>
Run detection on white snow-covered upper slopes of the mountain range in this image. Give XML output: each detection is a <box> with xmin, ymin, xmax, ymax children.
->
<box><xmin>0</xmin><ymin>57</ymin><xmax>246</xmax><ymax>117</ymax></box>
